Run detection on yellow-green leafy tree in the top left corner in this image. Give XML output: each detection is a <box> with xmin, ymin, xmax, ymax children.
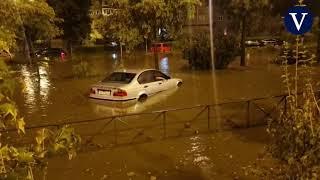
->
<box><xmin>0</xmin><ymin>0</ymin><xmax>59</xmax><ymax>63</ymax></box>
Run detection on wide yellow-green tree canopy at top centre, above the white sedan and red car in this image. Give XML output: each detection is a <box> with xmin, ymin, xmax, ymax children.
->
<box><xmin>97</xmin><ymin>0</ymin><xmax>200</xmax><ymax>66</ymax></box>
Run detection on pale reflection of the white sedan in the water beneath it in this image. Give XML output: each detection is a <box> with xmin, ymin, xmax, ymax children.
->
<box><xmin>90</xmin><ymin>88</ymin><xmax>179</xmax><ymax>116</ymax></box>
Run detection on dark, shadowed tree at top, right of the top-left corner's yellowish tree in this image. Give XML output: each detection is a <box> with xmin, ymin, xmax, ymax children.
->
<box><xmin>48</xmin><ymin>0</ymin><xmax>91</xmax><ymax>54</ymax></box>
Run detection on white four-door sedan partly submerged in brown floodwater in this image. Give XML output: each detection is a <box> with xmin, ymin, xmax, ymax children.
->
<box><xmin>89</xmin><ymin>69</ymin><xmax>182</xmax><ymax>102</ymax></box>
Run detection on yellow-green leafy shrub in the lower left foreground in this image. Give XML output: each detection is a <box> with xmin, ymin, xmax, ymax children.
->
<box><xmin>0</xmin><ymin>63</ymin><xmax>81</xmax><ymax>180</ymax></box>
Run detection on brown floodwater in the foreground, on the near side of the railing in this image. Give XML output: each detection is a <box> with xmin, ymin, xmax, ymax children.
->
<box><xmin>48</xmin><ymin>128</ymin><xmax>267</xmax><ymax>180</ymax></box>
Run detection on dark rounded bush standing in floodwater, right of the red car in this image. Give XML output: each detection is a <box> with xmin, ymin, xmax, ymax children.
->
<box><xmin>183</xmin><ymin>33</ymin><xmax>239</xmax><ymax>69</ymax></box>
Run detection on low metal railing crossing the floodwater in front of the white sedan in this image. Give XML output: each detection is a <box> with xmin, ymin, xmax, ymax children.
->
<box><xmin>4</xmin><ymin>91</ymin><xmax>296</xmax><ymax>148</ymax></box>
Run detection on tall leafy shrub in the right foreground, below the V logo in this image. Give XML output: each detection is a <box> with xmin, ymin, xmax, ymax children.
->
<box><xmin>268</xmin><ymin>39</ymin><xmax>320</xmax><ymax>179</ymax></box>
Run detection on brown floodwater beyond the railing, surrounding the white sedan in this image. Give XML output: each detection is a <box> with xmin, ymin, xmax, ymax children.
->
<box><xmin>14</xmin><ymin>48</ymin><xmax>283</xmax><ymax>125</ymax></box>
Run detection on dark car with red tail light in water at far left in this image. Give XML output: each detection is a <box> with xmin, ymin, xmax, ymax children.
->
<box><xmin>35</xmin><ymin>48</ymin><xmax>67</xmax><ymax>60</ymax></box>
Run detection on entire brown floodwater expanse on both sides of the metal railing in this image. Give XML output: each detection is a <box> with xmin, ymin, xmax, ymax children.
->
<box><xmin>9</xmin><ymin>48</ymin><xmax>318</xmax><ymax>180</ymax></box>
